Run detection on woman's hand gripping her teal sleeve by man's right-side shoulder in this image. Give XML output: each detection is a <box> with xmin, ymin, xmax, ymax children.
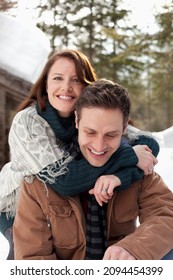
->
<box><xmin>133</xmin><ymin>145</ymin><xmax>158</xmax><ymax>175</ymax></box>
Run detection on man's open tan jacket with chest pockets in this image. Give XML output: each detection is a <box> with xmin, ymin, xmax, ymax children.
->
<box><xmin>14</xmin><ymin>173</ymin><xmax>173</xmax><ymax>260</ymax></box>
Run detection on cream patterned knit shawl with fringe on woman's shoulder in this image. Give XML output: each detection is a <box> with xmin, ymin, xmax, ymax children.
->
<box><xmin>0</xmin><ymin>106</ymin><xmax>73</xmax><ymax>216</ymax></box>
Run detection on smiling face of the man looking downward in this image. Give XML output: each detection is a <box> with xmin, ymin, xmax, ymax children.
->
<box><xmin>76</xmin><ymin>108</ymin><xmax>124</xmax><ymax>167</ymax></box>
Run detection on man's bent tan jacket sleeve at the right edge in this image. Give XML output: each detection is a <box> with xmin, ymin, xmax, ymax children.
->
<box><xmin>117</xmin><ymin>173</ymin><xmax>173</xmax><ymax>260</ymax></box>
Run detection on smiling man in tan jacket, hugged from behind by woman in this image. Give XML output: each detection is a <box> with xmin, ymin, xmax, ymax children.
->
<box><xmin>14</xmin><ymin>80</ymin><xmax>173</xmax><ymax>260</ymax></box>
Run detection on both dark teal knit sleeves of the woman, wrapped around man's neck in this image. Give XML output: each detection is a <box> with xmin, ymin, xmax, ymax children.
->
<box><xmin>38</xmin><ymin>134</ymin><xmax>159</xmax><ymax>196</ymax></box>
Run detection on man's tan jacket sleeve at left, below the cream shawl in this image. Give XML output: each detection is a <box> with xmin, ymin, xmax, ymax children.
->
<box><xmin>13</xmin><ymin>180</ymin><xmax>56</xmax><ymax>260</ymax></box>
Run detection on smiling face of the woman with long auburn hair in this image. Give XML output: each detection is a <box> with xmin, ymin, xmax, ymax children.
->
<box><xmin>46</xmin><ymin>57</ymin><xmax>84</xmax><ymax>118</ymax></box>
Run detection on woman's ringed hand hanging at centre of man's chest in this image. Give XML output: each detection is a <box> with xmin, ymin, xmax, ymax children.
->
<box><xmin>89</xmin><ymin>175</ymin><xmax>121</xmax><ymax>206</ymax></box>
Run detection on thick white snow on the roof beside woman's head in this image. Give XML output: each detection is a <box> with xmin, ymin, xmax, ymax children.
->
<box><xmin>0</xmin><ymin>13</ymin><xmax>51</xmax><ymax>83</ymax></box>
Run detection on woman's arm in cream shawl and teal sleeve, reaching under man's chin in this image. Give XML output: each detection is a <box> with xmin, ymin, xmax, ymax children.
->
<box><xmin>0</xmin><ymin>103</ymin><xmax>159</xmax><ymax>211</ymax></box>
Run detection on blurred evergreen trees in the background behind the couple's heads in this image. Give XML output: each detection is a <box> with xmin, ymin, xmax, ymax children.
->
<box><xmin>30</xmin><ymin>0</ymin><xmax>173</xmax><ymax>130</ymax></box>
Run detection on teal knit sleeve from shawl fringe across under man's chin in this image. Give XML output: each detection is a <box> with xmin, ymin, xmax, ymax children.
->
<box><xmin>37</xmin><ymin>146</ymin><xmax>138</xmax><ymax>196</ymax></box>
